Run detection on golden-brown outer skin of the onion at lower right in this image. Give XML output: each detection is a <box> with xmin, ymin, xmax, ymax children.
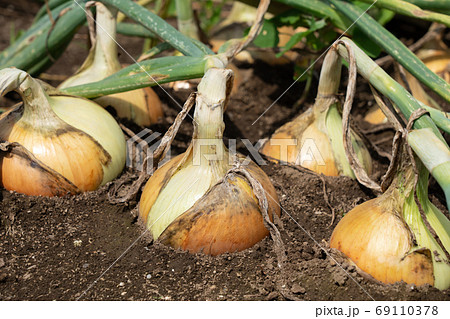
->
<box><xmin>330</xmin><ymin>197</ymin><xmax>434</xmax><ymax>286</ymax></box>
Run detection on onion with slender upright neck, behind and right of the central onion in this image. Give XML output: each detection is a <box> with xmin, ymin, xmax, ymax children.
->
<box><xmin>261</xmin><ymin>48</ymin><xmax>372</xmax><ymax>178</ymax></box>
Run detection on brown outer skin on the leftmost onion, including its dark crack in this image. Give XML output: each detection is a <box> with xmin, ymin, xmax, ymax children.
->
<box><xmin>0</xmin><ymin>106</ymin><xmax>111</xmax><ymax>196</ymax></box>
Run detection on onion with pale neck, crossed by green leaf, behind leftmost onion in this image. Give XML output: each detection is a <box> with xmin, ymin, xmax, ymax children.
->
<box><xmin>58</xmin><ymin>2</ymin><xmax>163</xmax><ymax>126</ymax></box>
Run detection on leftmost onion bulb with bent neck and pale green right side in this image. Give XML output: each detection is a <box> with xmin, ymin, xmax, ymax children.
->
<box><xmin>0</xmin><ymin>68</ymin><xmax>126</xmax><ymax>196</ymax></box>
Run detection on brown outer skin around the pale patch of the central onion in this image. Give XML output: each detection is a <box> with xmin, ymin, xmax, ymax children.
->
<box><xmin>139</xmin><ymin>150</ymin><xmax>280</xmax><ymax>256</ymax></box>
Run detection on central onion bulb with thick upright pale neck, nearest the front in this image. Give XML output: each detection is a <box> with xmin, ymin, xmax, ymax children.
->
<box><xmin>139</xmin><ymin>68</ymin><xmax>280</xmax><ymax>255</ymax></box>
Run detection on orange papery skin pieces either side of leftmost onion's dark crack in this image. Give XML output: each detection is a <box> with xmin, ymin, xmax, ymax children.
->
<box><xmin>0</xmin><ymin>111</ymin><xmax>107</xmax><ymax>196</ymax></box>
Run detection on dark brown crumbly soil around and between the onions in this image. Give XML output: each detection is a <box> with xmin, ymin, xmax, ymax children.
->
<box><xmin>0</xmin><ymin>0</ymin><xmax>450</xmax><ymax>300</ymax></box>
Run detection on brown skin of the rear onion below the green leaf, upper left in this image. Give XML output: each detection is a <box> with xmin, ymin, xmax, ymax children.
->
<box><xmin>95</xmin><ymin>87</ymin><xmax>164</xmax><ymax>126</ymax></box>
